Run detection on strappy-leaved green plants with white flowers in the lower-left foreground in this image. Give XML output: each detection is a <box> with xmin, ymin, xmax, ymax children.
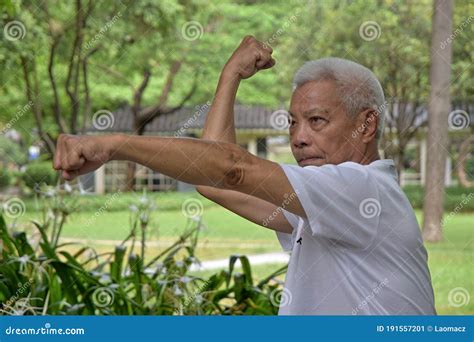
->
<box><xmin>0</xmin><ymin>185</ymin><xmax>286</xmax><ymax>315</ymax></box>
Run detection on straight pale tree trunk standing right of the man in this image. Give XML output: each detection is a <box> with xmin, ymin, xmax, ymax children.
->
<box><xmin>423</xmin><ymin>0</ymin><xmax>453</xmax><ymax>242</ymax></box>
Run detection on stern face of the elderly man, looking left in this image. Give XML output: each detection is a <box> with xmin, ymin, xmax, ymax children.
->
<box><xmin>289</xmin><ymin>81</ymin><xmax>361</xmax><ymax>166</ymax></box>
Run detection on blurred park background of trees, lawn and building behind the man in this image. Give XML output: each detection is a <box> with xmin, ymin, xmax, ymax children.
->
<box><xmin>0</xmin><ymin>0</ymin><xmax>474</xmax><ymax>314</ymax></box>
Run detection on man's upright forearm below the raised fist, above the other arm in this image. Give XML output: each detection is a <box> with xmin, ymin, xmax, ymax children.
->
<box><xmin>202</xmin><ymin>68</ymin><xmax>240</xmax><ymax>144</ymax></box>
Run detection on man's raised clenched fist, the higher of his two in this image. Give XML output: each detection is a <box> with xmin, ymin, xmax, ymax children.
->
<box><xmin>224</xmin><ymin>36</ymin><xmax>275</xmax><ymax>79</ymax></box>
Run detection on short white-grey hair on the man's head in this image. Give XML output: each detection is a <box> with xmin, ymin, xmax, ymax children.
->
<box><xmin>293</xmin><ymin>57</ymin><xmax>386</xmax><ymax>140</ymax></box>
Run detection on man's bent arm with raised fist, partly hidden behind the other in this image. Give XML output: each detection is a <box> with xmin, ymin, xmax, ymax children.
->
<box><xmin>196</xmin><ymin>36</ymin><xmax>292</xmax><ymax>232</ymax></box>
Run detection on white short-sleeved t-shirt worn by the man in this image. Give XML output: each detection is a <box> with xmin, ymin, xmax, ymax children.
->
<box><xmin>277</xmin><ymin>159</ymin><xmax>436</xmax><ymax>315</ymax></box>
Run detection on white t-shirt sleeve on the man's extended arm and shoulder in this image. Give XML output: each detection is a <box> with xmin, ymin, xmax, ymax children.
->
<box><xmin>280</xmin><ymin>163</ymin><xmax>382</xmax><ymax>248</ymax></box>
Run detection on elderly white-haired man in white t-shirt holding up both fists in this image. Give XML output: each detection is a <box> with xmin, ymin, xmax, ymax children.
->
<box><xmin>54</xmin><ymin>36</ymin><xmax>435</xmax><ymax>315</ymax></box>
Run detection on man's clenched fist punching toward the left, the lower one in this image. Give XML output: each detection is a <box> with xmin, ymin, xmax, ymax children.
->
<box><xmin>53</xmin><ymin>134</ymin><xmax>114</xmax><ymax>180</ymax></box>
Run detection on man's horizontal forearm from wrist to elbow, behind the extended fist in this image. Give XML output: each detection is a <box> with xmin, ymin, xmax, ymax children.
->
<box><xmin>109</xmin><ymin>135</ymin><xmax>246</xmax><ymax>188</ymax></box>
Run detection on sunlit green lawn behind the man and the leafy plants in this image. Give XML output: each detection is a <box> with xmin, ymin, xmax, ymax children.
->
<box><xmin>5</xmin><ymin>189</ymin><xmax>474</xmax><ymax>314</ymax></box>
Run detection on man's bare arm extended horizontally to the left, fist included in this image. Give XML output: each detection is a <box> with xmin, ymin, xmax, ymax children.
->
<box><xmin>53</xmin><ymin>134</ymin><xmax>305</xmax><ymax>222</ymax></box>
